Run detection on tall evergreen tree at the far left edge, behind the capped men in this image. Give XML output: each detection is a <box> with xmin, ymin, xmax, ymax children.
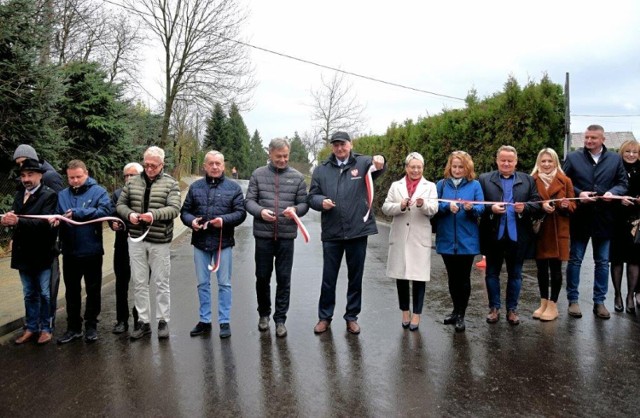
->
<box><xmin>0</xmin><ymin>0</ymin><xmax>66</xmax><ymax>172</ymax></box>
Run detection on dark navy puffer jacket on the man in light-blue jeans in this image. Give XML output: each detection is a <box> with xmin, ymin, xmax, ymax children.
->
<box><xmin>180</xmin><ymin>175</ymin><xmax>247</xmax><ymax>252</ymax></box>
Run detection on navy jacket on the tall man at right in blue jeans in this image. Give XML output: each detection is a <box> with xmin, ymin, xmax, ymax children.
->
<box><xmin>562</xmin><ymin>145</ymin><xmax>628</xmax><ymax>239</ymax></box>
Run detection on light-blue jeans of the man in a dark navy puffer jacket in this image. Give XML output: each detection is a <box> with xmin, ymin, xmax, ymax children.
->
<box><xmin>198</xmin><ymin>247</ymin><xmax>233</xmax><ymax>324</ymax></box>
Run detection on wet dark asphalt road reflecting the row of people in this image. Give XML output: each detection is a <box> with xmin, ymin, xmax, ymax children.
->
<box><xmin>0</xmin><ymin>212</ymin><xmax>640</xmax><ymax>417</ymax></box>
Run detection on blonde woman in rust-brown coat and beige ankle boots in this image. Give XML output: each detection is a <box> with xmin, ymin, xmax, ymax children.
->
<box><xmin>531</xmin><ymin>148</ymin><xmax>576</xmax><ymax>321</ymax></box>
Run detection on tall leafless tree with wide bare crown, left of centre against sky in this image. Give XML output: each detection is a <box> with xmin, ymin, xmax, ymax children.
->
<box><xmin>127</xmin><ymin>0</ymin><xmax>255</xmax><ymax>149</ymax></box>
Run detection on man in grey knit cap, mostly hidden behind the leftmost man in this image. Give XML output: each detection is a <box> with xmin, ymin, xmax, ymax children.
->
<box><xmin>13</xmin><ymin>144</ymin><xmax>65</xmax><ymax>327</ymax></box>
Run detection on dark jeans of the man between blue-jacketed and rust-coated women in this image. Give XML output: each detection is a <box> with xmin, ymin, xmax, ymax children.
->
<box><xmin>484</xmin><ymin>239</ymin><xmax>524</xmax><ymax>311</ymax></box>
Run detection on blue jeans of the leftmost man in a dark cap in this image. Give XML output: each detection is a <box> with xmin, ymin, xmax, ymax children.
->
<box><xmin>19</xmin><ymin>269</ymin><xmax>53</xmax><ymax>332</ymax></box>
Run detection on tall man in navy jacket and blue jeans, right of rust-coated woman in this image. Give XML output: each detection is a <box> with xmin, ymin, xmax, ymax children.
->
<box><xmin>562</xmin><ymin>125</ymin><xmax>628</xmax><ymax>319</ymax></box>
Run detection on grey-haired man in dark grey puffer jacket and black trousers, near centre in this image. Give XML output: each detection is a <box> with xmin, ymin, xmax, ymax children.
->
<box><xmin>244</xmin><ymin>138</ymin><xmax>309</xmax><ymax>337</ymax></box>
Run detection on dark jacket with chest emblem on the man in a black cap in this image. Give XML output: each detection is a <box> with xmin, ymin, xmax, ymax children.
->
<box><xmin>308</xmin><ymin>152</ymin><xmax>387</xmax><ymax>241</ymax></box>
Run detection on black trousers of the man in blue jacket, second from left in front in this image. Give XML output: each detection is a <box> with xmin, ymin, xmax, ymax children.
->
<box><xmin>62</xmin><ymin>255</ymin><xmax>102</xmax><ymax>332</ymax></box>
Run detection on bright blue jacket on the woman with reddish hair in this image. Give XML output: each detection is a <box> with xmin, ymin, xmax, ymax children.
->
<box><xmin>436</xmin><ymin>179</ymin><xmax>484</xmax><ymax>255</ymax></box>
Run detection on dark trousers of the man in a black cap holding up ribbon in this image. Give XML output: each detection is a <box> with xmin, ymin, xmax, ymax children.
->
<box><xmin>318</xmin><ymin>237</ymin><xmax>367</xmax><ymax>321</ymax></box>
